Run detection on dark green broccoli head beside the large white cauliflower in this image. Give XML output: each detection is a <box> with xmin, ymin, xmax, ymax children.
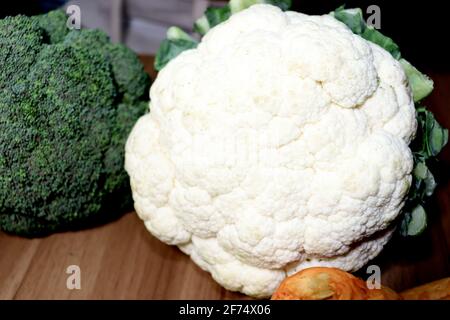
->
<box><xmin>0</xmin><ymin>11</ymin><xmax>150</xmax><ymax>237</ymax></box>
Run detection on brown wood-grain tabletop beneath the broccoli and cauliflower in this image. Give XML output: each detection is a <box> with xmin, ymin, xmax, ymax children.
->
<box><xmin>0</xmin><ymin>57</ymin><xmax>450</xmax><ymax>299</ymax></box>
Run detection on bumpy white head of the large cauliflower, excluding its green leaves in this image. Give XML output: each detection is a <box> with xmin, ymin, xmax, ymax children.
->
<box><xmin>125</xmin><ymin>5</ymin><xmax>417</xmax><ymax>297</ymax></box>
